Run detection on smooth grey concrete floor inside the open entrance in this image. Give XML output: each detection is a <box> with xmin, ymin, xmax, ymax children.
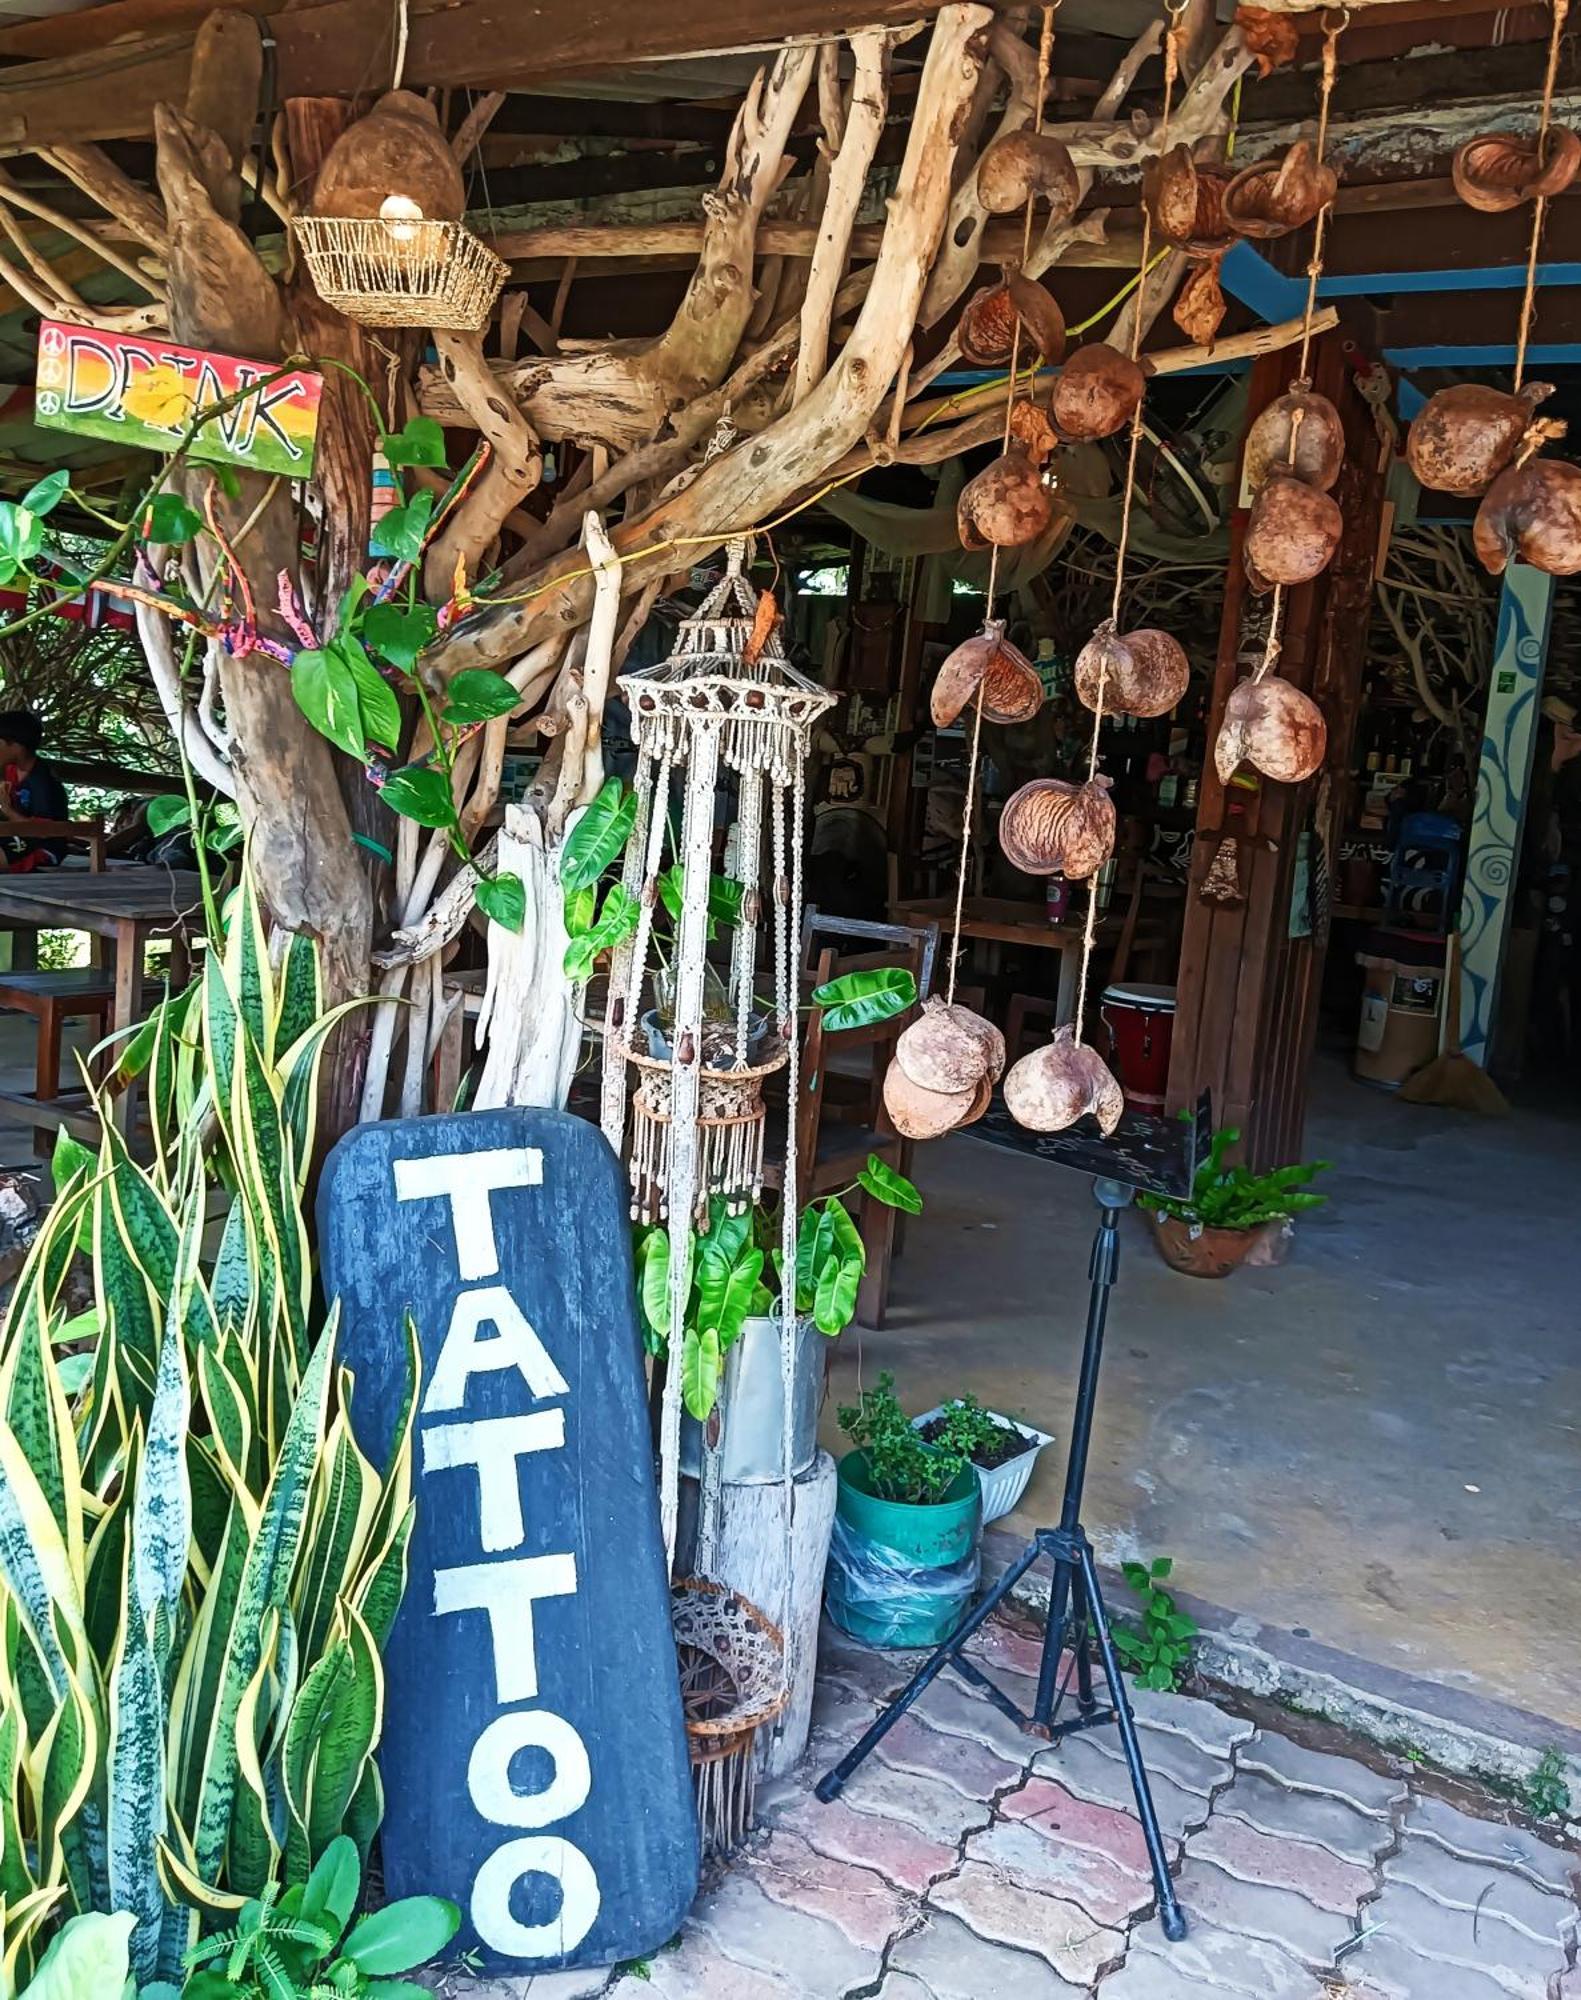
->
<box><xmin>827</xmin><ymin>1062</ymin><xmax>1581</xmax><ymax>1726</ymax></box>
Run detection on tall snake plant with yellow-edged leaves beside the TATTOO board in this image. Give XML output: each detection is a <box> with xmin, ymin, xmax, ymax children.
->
<box><xmin>0</xmin><ymin>882</ymin><xmax>416</xmax><ymax>1994</ymax></box>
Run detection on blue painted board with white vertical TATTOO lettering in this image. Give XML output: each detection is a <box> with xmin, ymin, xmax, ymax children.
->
<box><xmin>318</xmin><ymin>1110</ymin><xmax>696</xmax><ymax>1970</ymax></box>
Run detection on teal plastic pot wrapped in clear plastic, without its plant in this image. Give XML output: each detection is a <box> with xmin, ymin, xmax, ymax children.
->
<box><xmin>827</xmin><ymin>1452</ymin><xmax>983</xmax><ymax>1646</ymax></box>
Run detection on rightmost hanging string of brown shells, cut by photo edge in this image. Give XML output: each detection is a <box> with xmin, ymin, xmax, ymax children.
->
<box><xmin>1405</xmin><ymin>0</ymin><xmax>1581</xmax><ymax>576</ymax></box>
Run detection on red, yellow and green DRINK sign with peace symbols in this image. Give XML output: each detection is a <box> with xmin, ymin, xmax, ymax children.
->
<box><xmin>34</xmin><ymin>320</ymin><xmax>324</xmax><ymax>480</ymax></box>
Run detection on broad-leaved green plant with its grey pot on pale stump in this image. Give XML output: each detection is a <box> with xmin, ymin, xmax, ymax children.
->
<box><xmin>636</xmin><ymin>1154</ymin><xmax>923</xmax><ymax>1486</ymax></box>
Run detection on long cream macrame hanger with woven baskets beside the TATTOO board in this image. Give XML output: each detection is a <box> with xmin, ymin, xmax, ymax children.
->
<box><xmin>600</xmin><ymin>540</ymin><xmax>835</xmax><ymax>1848</ymax></box>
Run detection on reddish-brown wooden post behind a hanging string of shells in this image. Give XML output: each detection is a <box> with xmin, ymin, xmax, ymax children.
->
<box><xmin>1169</xmin><ymin>334</ymin><xmax>1387</xmax><ymax>1168</ymax></box>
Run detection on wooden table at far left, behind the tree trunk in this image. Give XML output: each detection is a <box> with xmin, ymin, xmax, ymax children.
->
<box><xmin>0</xmin><ymin>866</ymin><xmax>202</xmax><ymax>1132</ymax></box>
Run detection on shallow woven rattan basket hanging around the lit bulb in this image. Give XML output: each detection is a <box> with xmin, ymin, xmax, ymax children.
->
<box><xmin>292</xmin><ymin>216</ymin><xmax>508</xmax><ymax>334</ymax></box>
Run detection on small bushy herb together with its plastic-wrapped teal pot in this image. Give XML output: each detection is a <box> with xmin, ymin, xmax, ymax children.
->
<box><xmin>827</xmin><ymin>1374</ymin><xmax>983</xmax><ymax>1646</ymax></box>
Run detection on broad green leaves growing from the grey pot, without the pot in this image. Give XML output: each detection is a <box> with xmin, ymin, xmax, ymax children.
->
<box><xmin>636</xmin><ymin>1152</ymin><xmax>923</xmax><ymax>1424</ymax></box>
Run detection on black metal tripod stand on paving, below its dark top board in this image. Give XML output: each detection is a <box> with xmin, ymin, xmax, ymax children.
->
<box><xmin>817</xmin><ymin>1180</ymin><xmax>1187</xmax><ymax>1942</ymax></box>
